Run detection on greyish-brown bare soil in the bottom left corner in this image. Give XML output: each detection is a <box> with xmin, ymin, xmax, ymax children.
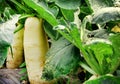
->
<box><xmin>0</xmin><ymin>68</ymin><xmax>28</xmax><ymax>84</ymax></box>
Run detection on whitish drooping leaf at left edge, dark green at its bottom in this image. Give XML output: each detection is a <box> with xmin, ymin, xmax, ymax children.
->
<box><xmin>0</xmin><ymin>15</ymin><xmax>19</xmax><ymax>66</ymax></box>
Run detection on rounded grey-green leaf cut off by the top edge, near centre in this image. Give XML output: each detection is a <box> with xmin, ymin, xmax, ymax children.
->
<box><xmin>55</xmin><ymin>0</ymin><xmax>80</xmax><ymax>10</ymax></box>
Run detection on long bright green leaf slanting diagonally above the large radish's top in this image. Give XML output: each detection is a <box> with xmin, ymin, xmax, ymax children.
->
<box><xmin>23</xmin><ymin>0</ymin><xmax>58</xmax><ymax>26</ymax></box>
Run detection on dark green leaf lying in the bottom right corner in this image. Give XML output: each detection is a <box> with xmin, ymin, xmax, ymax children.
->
<box><xmin>83</xmin><ymin>75</ymin><xmax>120</xmax><ymax>84</ymax></box>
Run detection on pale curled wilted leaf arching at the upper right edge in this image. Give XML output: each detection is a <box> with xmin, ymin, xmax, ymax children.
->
<box><xmin>92</xmin><ymin>7</ymin><xmax>120</xmax><ymax>25</ymax></box>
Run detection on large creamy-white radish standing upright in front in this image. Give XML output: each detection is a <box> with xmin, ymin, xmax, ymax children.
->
<box><xmin>24</xmin><ymin>17</ymin><xmax>49</xmax><ymax>84</ymax></box>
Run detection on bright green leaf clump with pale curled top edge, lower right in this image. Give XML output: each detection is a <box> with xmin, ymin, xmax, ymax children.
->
<box><xmin>84</xmin><ymin>33</ymin><xmax>120</xmax><ymax>75</ymax></box>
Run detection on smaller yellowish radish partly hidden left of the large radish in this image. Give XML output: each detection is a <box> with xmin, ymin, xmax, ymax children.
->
<box><xmin>6</xmin><ymin>28</ymin><xmax>24</xmax><ymax>69</ymax></box>
